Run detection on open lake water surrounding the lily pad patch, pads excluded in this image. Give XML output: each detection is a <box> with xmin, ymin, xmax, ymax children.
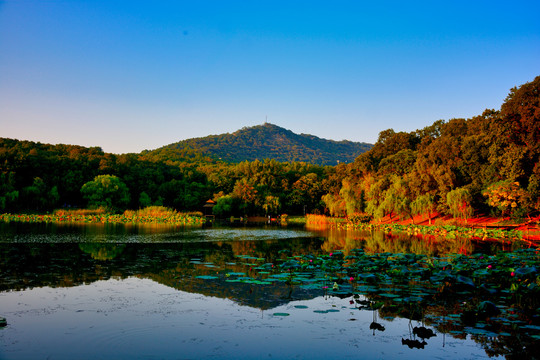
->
<box><xmin>0</xmin><ymin>223</ymin><xmax>538</xmax><ymax>359</ymax></box>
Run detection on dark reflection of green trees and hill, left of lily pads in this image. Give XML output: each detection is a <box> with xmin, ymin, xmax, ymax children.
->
<box><xmin>0</xmin><ymin>238</ymin><xmax>321</xmax><ymax>309</ymax></box>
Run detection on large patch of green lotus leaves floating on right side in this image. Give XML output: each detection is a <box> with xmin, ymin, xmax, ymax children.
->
<box><xmin>192</xmin><ymin>248</ymin><xmax>540</xmax><ymax>346</ymax></box>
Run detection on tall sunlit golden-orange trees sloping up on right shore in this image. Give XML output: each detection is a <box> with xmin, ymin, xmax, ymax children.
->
<box><xmin>323</xmin><ymin>76</ymin><xmax>540</xmax><ymax>219</ymax></box>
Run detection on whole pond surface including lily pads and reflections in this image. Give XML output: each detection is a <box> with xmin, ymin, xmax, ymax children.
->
<box><xmin>0</xmin><ymin>223</ymin><xmax>540</xmax><ymax>359</ymax></box>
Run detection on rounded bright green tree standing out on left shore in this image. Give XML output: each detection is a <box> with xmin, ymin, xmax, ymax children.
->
<box><xmin>81</xmin><ymin>175</ymin><xmax>129</xmax><ymax>212</ymax></box>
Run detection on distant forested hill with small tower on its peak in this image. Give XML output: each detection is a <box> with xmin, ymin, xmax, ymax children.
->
<box><xmin>143</xmin><ymin>123</ymin><xmax>372</xmax><ymax>165</ymax></box>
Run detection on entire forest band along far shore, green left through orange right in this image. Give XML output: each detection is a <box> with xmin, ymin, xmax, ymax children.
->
<box><xmin>0</xmin><ymin>76</ymin><xmax>540</xmax><ymax>219</ymax></box>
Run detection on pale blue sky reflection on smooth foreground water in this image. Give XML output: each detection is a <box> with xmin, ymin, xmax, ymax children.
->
<box><xmin>0</xmin><ymin>278</ymin><xmax>492</xmax><ymax>359</ymax></box>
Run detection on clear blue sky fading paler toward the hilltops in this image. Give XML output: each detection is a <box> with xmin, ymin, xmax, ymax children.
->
<box><xmin>0</xmin><ymin>0</ymin><xmax>540</xmax><ymax>153</ymax></box>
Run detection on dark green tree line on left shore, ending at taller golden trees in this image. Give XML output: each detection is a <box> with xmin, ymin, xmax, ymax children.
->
<box><xmin>0</xmin><ymin>138</ymin><xmax>333</xmax><ymax>216</ymax></box>
